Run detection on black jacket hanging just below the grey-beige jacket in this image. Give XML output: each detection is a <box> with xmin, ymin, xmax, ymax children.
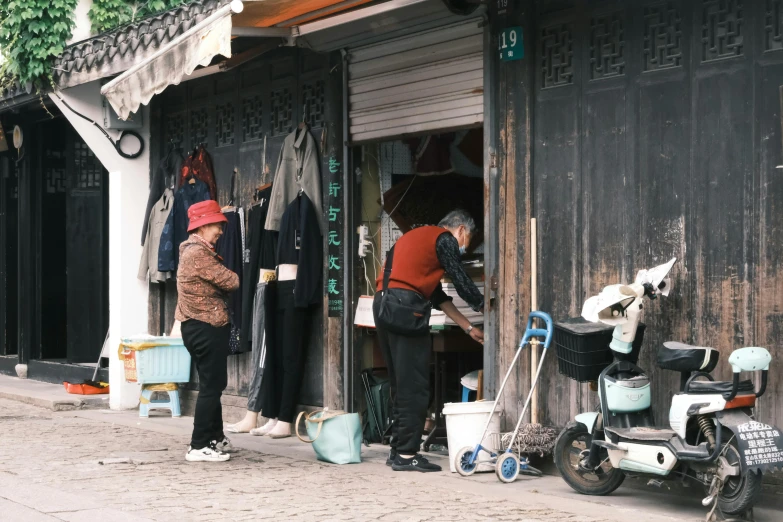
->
<box><xmin>277</xmin><ymin>194</ymin><xmax>324</xmax><ymax>308</ymax></box>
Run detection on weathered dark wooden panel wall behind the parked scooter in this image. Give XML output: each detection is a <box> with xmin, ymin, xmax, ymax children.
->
<box><xmin>491</xmin><ymin>0</ymin><xmax>783</xmax><ymax>426</ymax></box>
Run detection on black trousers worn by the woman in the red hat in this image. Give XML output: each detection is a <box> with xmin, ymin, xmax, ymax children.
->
<box><xmin>182</xmin><ymin>319</ymin><xmax>231</xmax><ymax>449</ymax></box>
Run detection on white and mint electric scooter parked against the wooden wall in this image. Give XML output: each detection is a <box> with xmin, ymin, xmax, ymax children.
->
<box><xmin>555</xmin><ymin>259</ymin><xmax>783</xmax><ymax>515</ymax></box>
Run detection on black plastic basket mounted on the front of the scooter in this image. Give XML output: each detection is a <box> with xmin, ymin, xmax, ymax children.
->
<box><xmin>554</xmin><ymin>317</ymin><xmax>645</xmax><ymax>382</ymax></box>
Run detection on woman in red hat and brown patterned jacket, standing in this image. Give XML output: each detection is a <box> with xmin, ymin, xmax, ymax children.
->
<box><xmin>174</xmin><ymin>200</ymin><xmax>239</xmax><ymax>462</ymax></box>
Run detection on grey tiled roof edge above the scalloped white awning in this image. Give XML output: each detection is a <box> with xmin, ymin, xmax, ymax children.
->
<box><xmin>53</xmin><ymin>0</ymin><xmax>230</xmax><ymax>88</ymax></box>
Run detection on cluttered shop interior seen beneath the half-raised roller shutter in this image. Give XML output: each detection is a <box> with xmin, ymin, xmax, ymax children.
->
<box><xmin>354</xmin><ymin>127</ymin><xmax>484</xmax><ymax>451</ymax></box>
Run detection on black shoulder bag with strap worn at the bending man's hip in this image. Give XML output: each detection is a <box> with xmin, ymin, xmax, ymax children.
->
<box><xmin>375</xmin><ymin>247</ymin><xmax>432</xmax><ymax>337</ymax></box>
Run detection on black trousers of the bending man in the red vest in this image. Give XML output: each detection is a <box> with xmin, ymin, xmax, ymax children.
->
<box><xmin>373</xmin><ymin>293</ymin><xmax>432</xmax><ymax>455</ymax></box>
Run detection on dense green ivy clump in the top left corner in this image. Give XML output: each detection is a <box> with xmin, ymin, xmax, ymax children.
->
<box><xmin>0</xmin><ymin>0</ymin><xmax>78</xmax><ymax>90</ymax></box>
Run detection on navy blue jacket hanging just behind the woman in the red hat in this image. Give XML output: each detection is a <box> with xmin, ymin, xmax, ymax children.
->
<box><xmin>158</xmin><ymin>179</ymin><xmax>210</xmax><ymax>272</ymax></box>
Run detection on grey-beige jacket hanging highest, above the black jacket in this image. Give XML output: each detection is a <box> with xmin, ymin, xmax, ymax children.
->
<box><xmin>264</xmin><ymin>126</ymin><xmax>326</xmax><ymax>234</ymax></box>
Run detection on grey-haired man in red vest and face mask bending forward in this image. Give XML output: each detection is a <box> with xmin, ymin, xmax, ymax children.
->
<box><xmin>373</xmin><ymin>210</ymin><xmax>484</xmax><ymax>472</ymax></box>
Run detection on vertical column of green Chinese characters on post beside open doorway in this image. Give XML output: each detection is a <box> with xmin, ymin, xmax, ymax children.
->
<box><xmin>326</xmin><ymin>155</ymin><xmax>345</xmax><ymax>317</ymax></box>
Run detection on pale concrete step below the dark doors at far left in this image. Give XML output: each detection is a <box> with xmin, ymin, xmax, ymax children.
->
<box><xmin>0</xmin><ymin>375</ymin><xmax>109</xmax><ymax>411</ymax></box>
